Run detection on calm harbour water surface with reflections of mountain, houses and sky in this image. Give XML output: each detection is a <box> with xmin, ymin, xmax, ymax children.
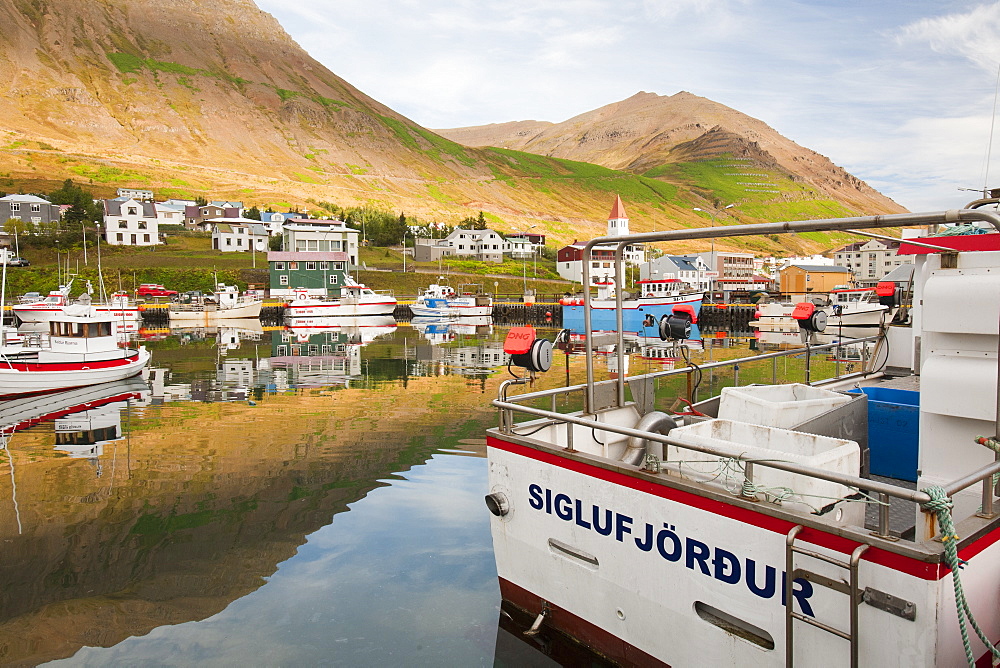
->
<box><xmin>0</xmin><ymin>322</ymin><xmax>796</xmax><ymax>666</ymax></box>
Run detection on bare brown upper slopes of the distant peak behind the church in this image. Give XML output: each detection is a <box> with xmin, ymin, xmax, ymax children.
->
<box><xmin>435</xmin><ymin>92</ymin><xmax>904</xmax><ymax>213</ymax></box>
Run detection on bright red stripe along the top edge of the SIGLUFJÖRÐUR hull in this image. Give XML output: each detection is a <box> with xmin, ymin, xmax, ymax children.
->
<box><xmin>486</xmin><ymin>435</ymin><xmax>988</xmax><ymax>580</ymax></box>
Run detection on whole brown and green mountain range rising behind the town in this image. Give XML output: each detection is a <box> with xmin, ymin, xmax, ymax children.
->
<box><xmin>0</xmin><ymin>0</ymin><xmax>899</xmax><ymax>252</ymax></box>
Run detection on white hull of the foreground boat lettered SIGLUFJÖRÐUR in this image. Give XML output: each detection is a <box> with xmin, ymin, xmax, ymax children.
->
<box><xmin>487</xmin><ymin>433</ymin><xmax>1000</xmax><ymax>667</ymax></box>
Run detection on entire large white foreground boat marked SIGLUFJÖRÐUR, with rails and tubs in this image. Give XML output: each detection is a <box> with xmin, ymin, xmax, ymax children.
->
<box><xmin>486</xmin><ymin>209</ymin><xmax>1000</xmax><ymax>666</ymax></box>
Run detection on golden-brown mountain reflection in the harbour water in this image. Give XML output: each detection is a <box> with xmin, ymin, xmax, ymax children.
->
<box><xmin>0</xmin><ymin>376</ymin><xmax>504</xmax><ymax>664</ymax></box>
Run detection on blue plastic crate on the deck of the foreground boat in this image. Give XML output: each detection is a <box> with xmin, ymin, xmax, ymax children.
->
<box><xmin>852</xmin><ymin>387</ymin><xmax>920</xmax><ymax>482</ymax></box>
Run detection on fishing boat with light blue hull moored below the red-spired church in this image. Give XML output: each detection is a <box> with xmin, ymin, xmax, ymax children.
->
<box><xmin>559</xmin><ymin>277</ymin><xmax>705</xmax><ymax>332</ymax></box>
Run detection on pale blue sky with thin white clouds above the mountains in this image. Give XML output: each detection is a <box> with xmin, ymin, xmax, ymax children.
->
<box><xmin>257</xmin><ymin>0</ymin><xmax>1000</xmax><ymax>211</ymax></box>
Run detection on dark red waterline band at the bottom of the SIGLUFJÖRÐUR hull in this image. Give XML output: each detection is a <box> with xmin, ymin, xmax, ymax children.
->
<box><xmin>497</xmin><ymin>578</ymin><xmax>669</xmax><ymax>668</ymax></box>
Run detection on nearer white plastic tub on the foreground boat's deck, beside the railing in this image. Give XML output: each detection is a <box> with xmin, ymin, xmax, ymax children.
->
<box><xmin>667</xmin><ymin>419</ymin><xmax>864</xmax><ymax>525</ymax></box>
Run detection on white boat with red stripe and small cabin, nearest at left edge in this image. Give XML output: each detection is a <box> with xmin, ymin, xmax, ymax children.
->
<box><xmin>0</xmin><ymin>306</ymin><xmax>149</xmax><ymax>399</ymax></box>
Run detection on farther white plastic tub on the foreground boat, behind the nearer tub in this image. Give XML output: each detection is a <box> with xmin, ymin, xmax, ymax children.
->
<box><xmin>719</xmin><ymin>383</ymin><xmax>851</xmax><ymax>429</ymax></box>
